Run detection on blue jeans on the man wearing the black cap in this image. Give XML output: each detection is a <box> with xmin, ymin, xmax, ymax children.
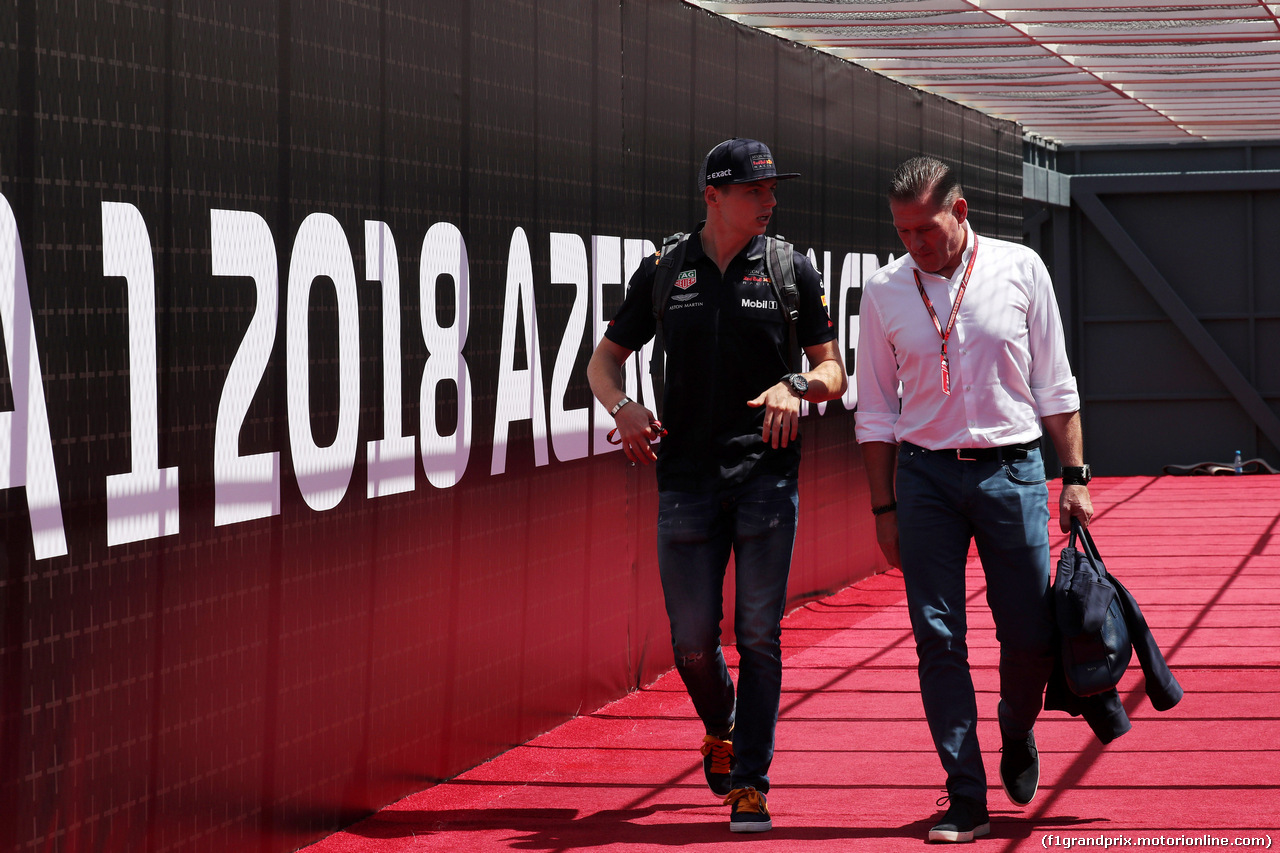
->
<box><xmin>658</xmin><ymin>476</ymin><xmax>800</xmax><ymax>792</ymax></box>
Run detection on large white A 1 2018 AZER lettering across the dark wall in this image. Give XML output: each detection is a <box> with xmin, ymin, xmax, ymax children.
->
<box><xmin>0</xmin><ymin>195</ymin><xmax>878</xmax><ymax>560</ymax></box>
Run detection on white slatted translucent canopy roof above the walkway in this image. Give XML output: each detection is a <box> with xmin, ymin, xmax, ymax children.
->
<box><xmin>686</xmin><ymin>0</ymin><xmax>1280</xmax><ymax>145</ymax></box>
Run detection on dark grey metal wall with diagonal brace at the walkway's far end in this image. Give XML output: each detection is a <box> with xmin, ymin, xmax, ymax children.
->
<box><xmin>1028</xmin><ymin>142</ymin><xmax>1280</xmax><ymax>474</ymax></box>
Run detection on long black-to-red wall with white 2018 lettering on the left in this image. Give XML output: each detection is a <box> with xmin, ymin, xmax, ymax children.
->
<box><xmin>0</xmin><ymin>0</ymin><xmax>1020</xmax><ymax>853</ymax></box>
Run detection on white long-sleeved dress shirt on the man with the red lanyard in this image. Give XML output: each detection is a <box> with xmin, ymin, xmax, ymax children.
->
<box><xmin>856</xmin><ymin>224</ymin><xmax>1080</xmax><ymax>450</ymax></box>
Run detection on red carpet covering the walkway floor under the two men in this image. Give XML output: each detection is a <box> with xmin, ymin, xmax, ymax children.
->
<box><xmin>307</xmin><ymin>476</ymin><xmax>1280</xmax><ymax>853</ymax></box>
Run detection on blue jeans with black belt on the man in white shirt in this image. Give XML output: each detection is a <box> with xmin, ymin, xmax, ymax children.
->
<box><xmin>896</xmin><ymin>442</ymin><xmax>1053</xmax><ymax>802</ymax></box>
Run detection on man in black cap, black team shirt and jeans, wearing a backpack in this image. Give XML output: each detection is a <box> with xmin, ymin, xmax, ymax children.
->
<box><xmin>588</xmin><ymin>138</ymin><xmax>847</xmax><ymax>833</ymax></box>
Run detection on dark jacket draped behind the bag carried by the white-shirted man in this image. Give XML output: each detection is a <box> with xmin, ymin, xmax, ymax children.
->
<box><xmin>1044</xmin><ymin>522</ymin><xmax>1183</xmax><ymax>743</ymax></box>
